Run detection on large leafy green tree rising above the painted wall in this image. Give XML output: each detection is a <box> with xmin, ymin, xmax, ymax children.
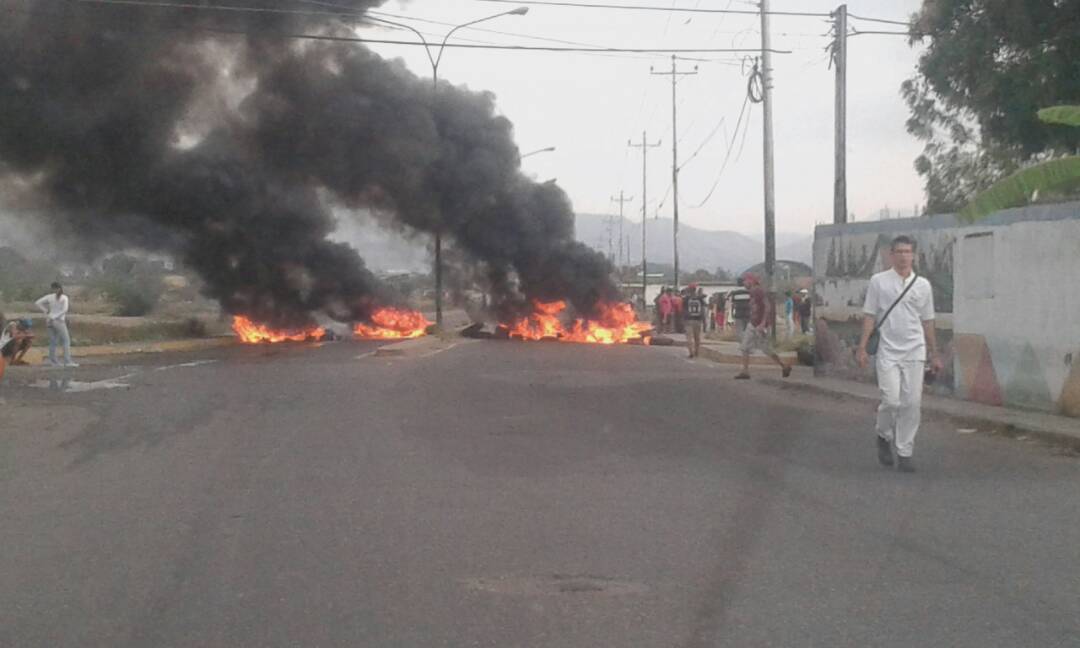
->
<box><xmin>901</xmin><ymin>0</ymin><xmax>1080</xmax><ymax>213</ymax></box>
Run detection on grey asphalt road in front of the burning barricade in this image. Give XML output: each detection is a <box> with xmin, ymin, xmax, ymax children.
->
<box><xmin>0</xmin><ymin>341</ymin><xmax>1080</xmax><ymax>648</ymax></box>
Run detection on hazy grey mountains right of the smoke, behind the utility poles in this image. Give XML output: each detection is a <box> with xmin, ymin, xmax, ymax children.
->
<box><xmin>576</xmin><ymin>214</ymin><xmax>813</xmax><ymax>272</ymax></box>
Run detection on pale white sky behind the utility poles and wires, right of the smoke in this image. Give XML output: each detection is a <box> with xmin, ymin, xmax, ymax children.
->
<box><xmin>365</xmin><ymin>0</ymin><xmax>923</xmax><ymax>235</ymax></box>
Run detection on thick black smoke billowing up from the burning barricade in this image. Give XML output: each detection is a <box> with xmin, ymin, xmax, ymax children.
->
<box><xmin>0</xmin><ymin>0</ymin><xmax>617</xmax><ymax>326</ymax></box>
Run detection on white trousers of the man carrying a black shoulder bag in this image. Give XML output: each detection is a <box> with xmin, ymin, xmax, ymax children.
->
<box><xmin>876</xmin><ymin>355</ymin><xmax>926</xmax><ymax>457</ymax></box>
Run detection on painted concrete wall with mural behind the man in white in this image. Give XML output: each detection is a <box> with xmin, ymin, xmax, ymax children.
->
<box><xmin>814</xmin><ymin>203</ymin><xmax>1080</xmax><ymax>417</ymax></box>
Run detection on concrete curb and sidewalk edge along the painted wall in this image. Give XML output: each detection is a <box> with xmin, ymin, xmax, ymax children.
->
<box><xmin>757</xmin><ymin>378</ymin><xmax>1080</xmax><ymax>453</ymax></box>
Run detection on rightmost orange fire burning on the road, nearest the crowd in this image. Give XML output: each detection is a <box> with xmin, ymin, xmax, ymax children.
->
<box><xmin>507</xmin><ymin>301</ymin><xmax>651</xmax><ymax>345</ymax></box>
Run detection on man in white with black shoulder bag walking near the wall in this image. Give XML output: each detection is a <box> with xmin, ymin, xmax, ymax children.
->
<box><xmin>858</xmin><ymin>237</ymin><xmax>943</xmax><ymax>472</ymax></box>
